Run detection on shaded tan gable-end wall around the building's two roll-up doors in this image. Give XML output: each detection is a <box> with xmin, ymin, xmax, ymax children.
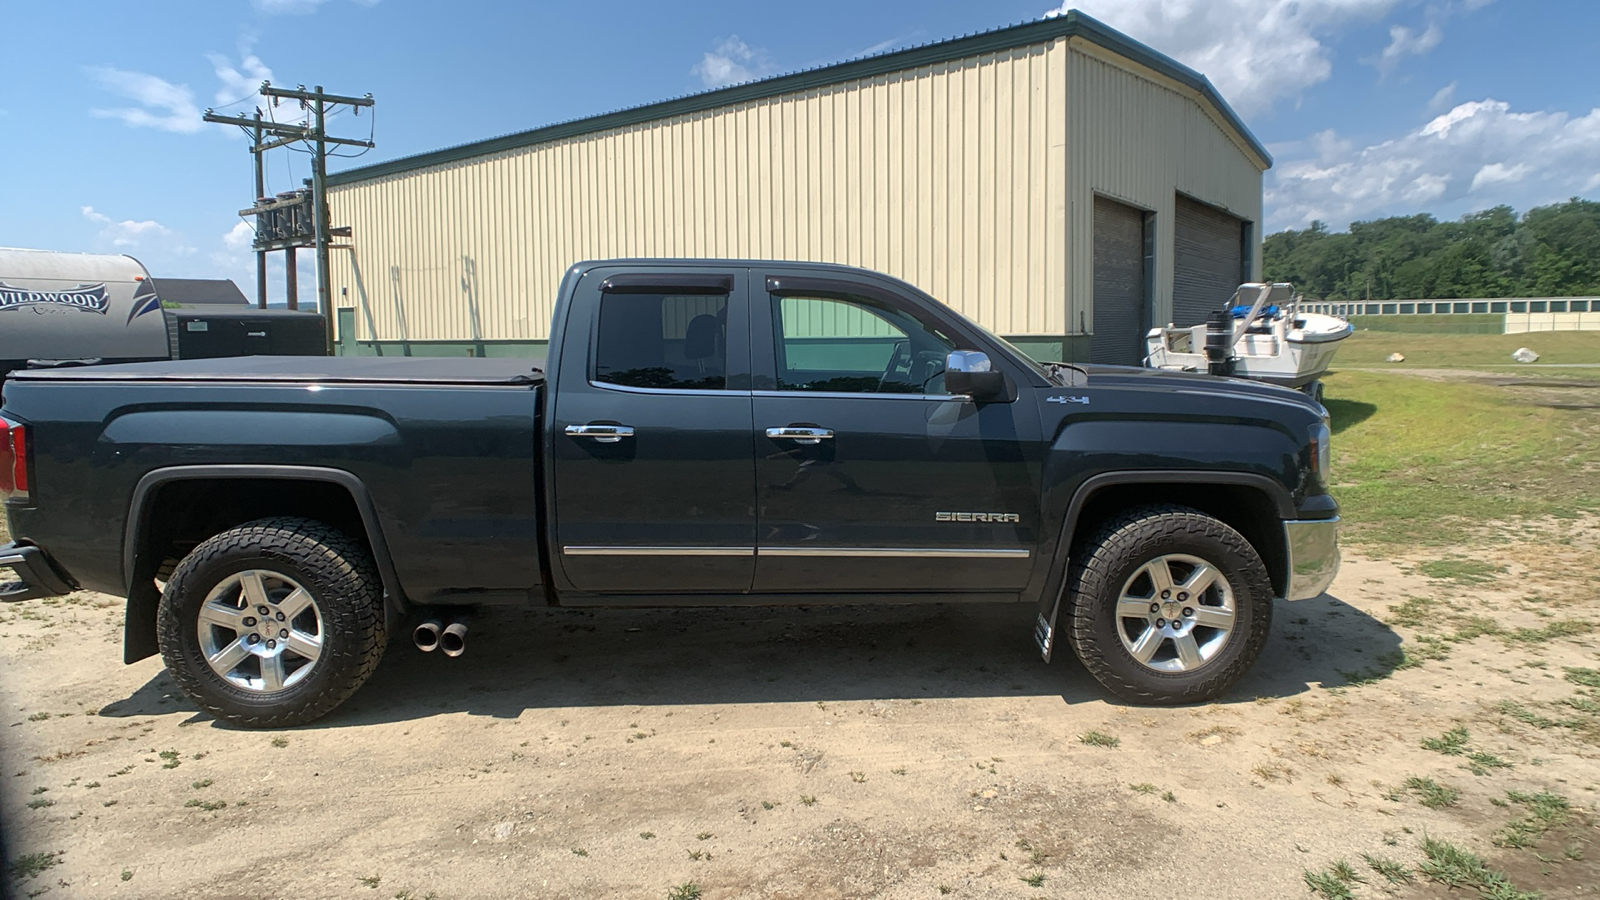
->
<box><xmin>1066</xmin><ymin>42</ymin><xmax>1262</xmax><ymax>331</ymax></box>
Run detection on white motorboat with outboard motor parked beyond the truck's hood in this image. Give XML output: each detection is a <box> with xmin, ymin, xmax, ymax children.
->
<box><xmin>1144</xmin><ymin>282</ymin><xmax>1355</xmax><ymax>402</ymax></box>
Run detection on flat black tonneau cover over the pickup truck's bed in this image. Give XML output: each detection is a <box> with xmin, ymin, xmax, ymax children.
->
<box><xmin>11</xmin><ymin>356</ymin><xmax>544</xmax><ymax>384</ymax></box>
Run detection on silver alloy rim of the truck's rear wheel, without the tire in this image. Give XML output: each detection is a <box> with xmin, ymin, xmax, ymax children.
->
<box><xmin>197</xmin><ymin>569</ymin><xmax>325</xmax><ymax>693</ymax></box>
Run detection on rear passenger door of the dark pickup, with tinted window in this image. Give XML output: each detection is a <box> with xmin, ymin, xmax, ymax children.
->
<box><xmin>549</xmin><ymin>266</ymin><xmax>755</xmax><ymax>594</ymax></box>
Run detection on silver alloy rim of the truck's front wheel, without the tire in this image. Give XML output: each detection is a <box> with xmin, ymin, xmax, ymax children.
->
<box><xmin>1117</xmin><ymin>552</ymin><xmax>1238</xmax><ymax>674</ymax></box>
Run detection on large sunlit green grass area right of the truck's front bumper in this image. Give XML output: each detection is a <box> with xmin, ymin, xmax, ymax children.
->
<box><xmin>1325</xmin><ymin>366</ymin><xmax>1600</xmax><ymax>547</ymax></box>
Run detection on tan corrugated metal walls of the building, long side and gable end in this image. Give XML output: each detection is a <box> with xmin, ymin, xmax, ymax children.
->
<box><xmin>330</xmin><ymin>40</ymin><xmax>1261</xmax><ymax>341</ymax></box>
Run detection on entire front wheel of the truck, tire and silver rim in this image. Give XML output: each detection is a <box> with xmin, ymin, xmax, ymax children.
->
<box><xmin>1067</xmin><ymin>506</ymin><xmax>1272</xmax><ymax>703</ymax></box>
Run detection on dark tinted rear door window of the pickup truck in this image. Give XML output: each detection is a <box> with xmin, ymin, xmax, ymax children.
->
<box><xmin>594</xmin><ymin>293</ymin><xmax>728</xmax><ymax>391</ymax></box>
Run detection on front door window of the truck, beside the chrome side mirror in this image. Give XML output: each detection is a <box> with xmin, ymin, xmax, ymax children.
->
<box><xmin>773</xmin><ymin>295</ymin><xmax>955</xmax><ymax>394</ymax></box>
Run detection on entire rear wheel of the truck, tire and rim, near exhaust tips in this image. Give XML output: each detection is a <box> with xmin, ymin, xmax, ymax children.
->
<box><xmin>157</xmin><ymin>519</ymin><xmax>386</xmax><ymax>727</ymax></box>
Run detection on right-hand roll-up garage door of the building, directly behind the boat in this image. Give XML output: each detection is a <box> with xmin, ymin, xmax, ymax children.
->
<box><xmin>1171</xmin><ymin>194</ymin><xmax>1248</xmax><ymax>325</ymax></box>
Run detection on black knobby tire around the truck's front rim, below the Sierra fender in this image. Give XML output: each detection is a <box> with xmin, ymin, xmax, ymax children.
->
<box><xmin>1066</xmin><ymin>504</ymin><xmax>1272</xmax><ymax>705</ymax></box>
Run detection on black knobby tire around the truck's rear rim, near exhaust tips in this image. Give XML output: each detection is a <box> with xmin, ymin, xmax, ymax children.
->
<box><xmin>157</xmin><ymin>517</ymin><xmax>387</xmax><ymax>729</ymax></box>
